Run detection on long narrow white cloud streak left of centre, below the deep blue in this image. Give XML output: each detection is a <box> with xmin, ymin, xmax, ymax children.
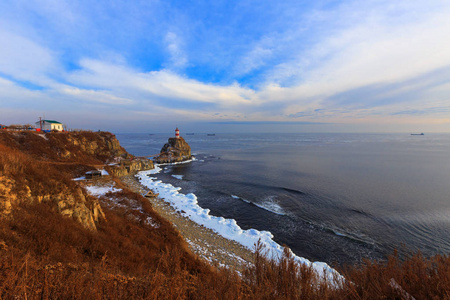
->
<box><xmin>67</xmin><ymin>59</ymin><xmax>256</xmax><ymax>107</ymax></box>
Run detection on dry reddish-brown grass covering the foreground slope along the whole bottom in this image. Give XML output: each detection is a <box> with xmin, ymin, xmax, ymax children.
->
<box><xmin>0</xmin><ymin>197</ymin><xmax>450</xmax><ymax>299</ymax></box>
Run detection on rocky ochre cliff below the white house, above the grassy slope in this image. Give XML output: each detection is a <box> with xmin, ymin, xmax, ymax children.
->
<box><xmin>0</xmin><ymin>131</ymin><xmax>153</xmax><ymax>230</ymax></box>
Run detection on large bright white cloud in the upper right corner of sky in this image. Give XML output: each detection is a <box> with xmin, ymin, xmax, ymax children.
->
<box><xmin>269</xmin><ymin>4</ymin><xmax>450</xmax><ymax>89</ymax></box>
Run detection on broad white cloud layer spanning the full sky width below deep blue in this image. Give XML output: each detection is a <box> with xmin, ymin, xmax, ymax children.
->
<box><xmin>0</xmin><ymin>1</ymin><xmax>450</xmax><ymax>131</ymax></box>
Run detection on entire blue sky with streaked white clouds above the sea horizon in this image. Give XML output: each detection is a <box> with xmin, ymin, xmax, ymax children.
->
<box><xmin>0</xmin><ymin>0</ymin><xmax>450</xmax><ymax>133</ymax></box>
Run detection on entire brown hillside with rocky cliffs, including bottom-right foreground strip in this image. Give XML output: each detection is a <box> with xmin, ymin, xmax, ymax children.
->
<box><xmin>0</xmin><ymin>131</ymin><xmax>450</xmax><ymax>299</ymax></box>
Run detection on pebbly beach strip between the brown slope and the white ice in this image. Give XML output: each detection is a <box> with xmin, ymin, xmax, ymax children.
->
<box><xmin>120</xmin><ymin>174</ymin><xmax>255</xmax><ymax>272</ymax></box>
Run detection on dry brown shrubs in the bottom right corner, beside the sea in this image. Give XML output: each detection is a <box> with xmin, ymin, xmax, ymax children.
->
<box><xmin>341</xmin><ymin>253</ymin><xmax>450</xmax><ymax>299</ymax></box>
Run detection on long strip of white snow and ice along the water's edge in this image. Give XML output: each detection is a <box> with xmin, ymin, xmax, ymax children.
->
<box><xmin>136</xmin><ymin>165</ymin><xmax>343</xmax><ymax>282</ymax></box>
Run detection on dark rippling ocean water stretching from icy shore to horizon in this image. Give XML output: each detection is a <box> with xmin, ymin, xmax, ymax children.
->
<box><xmin>117</xmin><ymin>133</ymin><xmax>450</xmax><ymax>265</ymax></box>
